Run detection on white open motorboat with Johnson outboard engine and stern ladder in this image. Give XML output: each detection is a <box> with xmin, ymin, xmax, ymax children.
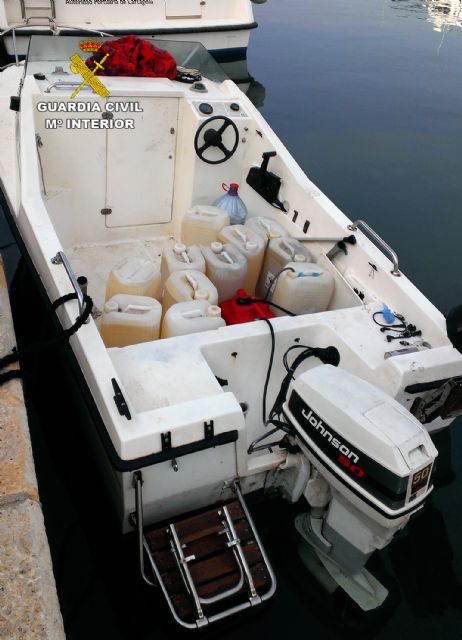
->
<box><xmin>0</xmin><ymin>36</ymin><xmax>462</xmax><ymax>628</ymax></box>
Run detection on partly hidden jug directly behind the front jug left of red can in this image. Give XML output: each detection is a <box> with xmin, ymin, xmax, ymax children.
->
<box><xmin>162</xmin><ymin>269</ymin><xmax>218</xmax><ymax>314</ymax></box>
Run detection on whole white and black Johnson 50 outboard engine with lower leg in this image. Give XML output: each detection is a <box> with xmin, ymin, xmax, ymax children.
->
<box><xmin>283</xmin><ymin>365</ymin><xmax>438</xmax><ymax>610</ymax></box>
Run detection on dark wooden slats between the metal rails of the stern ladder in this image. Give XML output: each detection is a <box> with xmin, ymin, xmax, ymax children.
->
<box><xmin>146</xmin><ymin>500</ymin><xmax>271</xmax><ymax>622</ymax></box>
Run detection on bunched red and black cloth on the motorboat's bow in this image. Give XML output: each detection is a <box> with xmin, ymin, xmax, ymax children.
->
<box><xmin>87</xmin><ymin>36</ymin><xmax>176</xmax><ymax>80</ymax></box>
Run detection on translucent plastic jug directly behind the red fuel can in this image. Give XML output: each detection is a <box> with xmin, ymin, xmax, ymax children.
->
<box><xmin>202</xmin><ymin>242</ymin><xmax>247</xmax><ymax>302</ymax></box>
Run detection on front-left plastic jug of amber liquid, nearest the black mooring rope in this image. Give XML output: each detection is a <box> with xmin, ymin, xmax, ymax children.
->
<box><xmin>101</xmin><ymin>293</ymin><xmax>162</xmax><ymax>347</ymax></box>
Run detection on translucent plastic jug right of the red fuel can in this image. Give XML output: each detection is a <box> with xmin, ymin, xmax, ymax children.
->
<box><xmin>271</xmin><ymin>262</ymin><xmax>334</xmax><ymax>316</ymax></box>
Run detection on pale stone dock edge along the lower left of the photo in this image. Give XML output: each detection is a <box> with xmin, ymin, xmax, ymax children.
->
<box><xmin>0</xmin><ymin>258</ymin><xmax>65</xmax><ymax>640</ymax></box>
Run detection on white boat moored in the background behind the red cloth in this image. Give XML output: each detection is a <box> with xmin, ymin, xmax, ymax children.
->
<box><xmin>0</xmin><ymin>0</ymin><xmax>257</xmax><ymax>66</ymax></box>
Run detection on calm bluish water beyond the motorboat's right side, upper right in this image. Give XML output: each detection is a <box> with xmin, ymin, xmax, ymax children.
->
<box><xmin>248</xmin><ymin>0</ymin><xmax>462</xmax><ymax>311</ymax></box>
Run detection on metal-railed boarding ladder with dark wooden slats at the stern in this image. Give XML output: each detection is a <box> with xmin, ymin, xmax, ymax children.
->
<box><xmin>133</xmin><ymin>472</ymin><xmax>276</xmax><ymax>629</ymax></box>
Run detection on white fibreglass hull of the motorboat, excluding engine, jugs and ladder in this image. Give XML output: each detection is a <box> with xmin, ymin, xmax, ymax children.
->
<box><xmin>3</xmin><ymin>52</ymin><xmax>462</xmax><ymax>531</ymax></box>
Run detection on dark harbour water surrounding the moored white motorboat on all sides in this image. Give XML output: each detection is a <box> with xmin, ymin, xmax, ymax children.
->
<box><xmin>0</xmin><ymin>0</ymin><xmax>462</xmax><ymax>640</ymax></box>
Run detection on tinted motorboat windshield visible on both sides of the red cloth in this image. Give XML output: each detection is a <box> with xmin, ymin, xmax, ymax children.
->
<box><xmin>27</xmin><ymin>34</ymin><xmax>228</xmax><ymax>82</ymax></box>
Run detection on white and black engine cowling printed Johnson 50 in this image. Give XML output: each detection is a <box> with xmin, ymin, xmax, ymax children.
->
<box><xmin>284</xmin><ymin>365</ymin><xmax>438</xmax><ymax>527</ymax></box>
